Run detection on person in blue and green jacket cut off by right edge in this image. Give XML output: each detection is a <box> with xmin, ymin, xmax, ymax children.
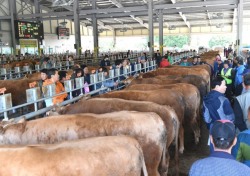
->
<box><xmin>232</xmin><ymin>106</ymin><xmax>250</xmax><ymax>167</ymax></box>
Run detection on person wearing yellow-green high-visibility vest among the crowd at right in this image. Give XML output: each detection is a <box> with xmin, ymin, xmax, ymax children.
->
<box><xmin>220</xmin><ymin>60</ymin><xmax>235</xmax><ymax>102</ymax></box>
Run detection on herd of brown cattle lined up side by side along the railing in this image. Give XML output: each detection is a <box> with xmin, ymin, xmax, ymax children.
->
<box><xmin>0</xmin><ymin>51</ymin><xmax>217</xmax><ymax>176</ymax></box>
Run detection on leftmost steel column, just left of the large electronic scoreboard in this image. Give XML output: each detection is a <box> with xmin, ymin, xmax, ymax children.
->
<box><xmin>9</xmin><ymin>0</ymin><xmax>17</xmax><ymax>55</ymax></box>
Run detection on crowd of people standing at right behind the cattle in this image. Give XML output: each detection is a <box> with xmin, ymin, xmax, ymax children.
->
<box><xmin>189</xmin><ymin>51</ymin><xmax>250</xmax><ymax>176</ymax></box>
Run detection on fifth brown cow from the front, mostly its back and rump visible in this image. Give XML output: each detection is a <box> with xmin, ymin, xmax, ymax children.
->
<box><xmin>126</xmin><ymin>83</ymin><xmax>200</xmax><ymax>144</ymax></box>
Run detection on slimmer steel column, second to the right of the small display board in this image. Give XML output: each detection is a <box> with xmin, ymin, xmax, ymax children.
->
<box><xmin>92</xmin><ymin>0</ymin><xmax>99</xmax><ymax>59</ymax></box>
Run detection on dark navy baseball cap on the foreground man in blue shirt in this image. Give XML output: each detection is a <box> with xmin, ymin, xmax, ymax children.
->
<box><xmin>211</xmin><ymin>120</ymin><xmax>236</xmax><ymax>142</ymax></box>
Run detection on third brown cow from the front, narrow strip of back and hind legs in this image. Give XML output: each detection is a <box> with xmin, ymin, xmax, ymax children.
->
<box><xmin>51</xmin><ymin>98</ymin><xmax>179</xmax><ymax>172</ymax></box>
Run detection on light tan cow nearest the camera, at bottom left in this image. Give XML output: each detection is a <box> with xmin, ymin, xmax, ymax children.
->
<box><xmin>0</xmin><ymin>136</ymin><xmax>148</xmax><ymax>176</ymax></box>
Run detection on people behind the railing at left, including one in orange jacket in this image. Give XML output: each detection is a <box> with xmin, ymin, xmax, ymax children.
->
<box><xmin>30</xmin><ymin>56</ymin><xmax>139</xmax><ymax>107</ymax></box>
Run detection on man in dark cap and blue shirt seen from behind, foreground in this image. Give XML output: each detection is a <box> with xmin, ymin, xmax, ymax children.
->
<box><xmin>189</xmin><ymin>120</ymin><xmax>250</xmax><ymax>176</ymax></box>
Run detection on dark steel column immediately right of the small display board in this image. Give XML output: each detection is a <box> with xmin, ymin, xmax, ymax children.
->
<box><xmin>73</xmin><ymin>0</ymin><xmax>82</xmax><ymax>57</ymax></box>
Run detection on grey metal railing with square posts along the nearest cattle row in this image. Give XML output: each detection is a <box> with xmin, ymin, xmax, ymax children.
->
<box><xmin>0</xmin><ymin>61</ymin><xmax>157</xmax><ymax>120</ymax></box>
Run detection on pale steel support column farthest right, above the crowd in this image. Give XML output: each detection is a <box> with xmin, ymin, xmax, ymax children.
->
<box><xmin>237</xmin><ymin>0</ymin><xmax>243</xmax><ymax>55</ymax></box>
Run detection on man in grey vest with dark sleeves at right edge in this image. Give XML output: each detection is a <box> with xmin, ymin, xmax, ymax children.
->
<box><xmin>233</xmin><ymin>73</ymin><xmax>250</xmax><ymax>131</ymax></box>
